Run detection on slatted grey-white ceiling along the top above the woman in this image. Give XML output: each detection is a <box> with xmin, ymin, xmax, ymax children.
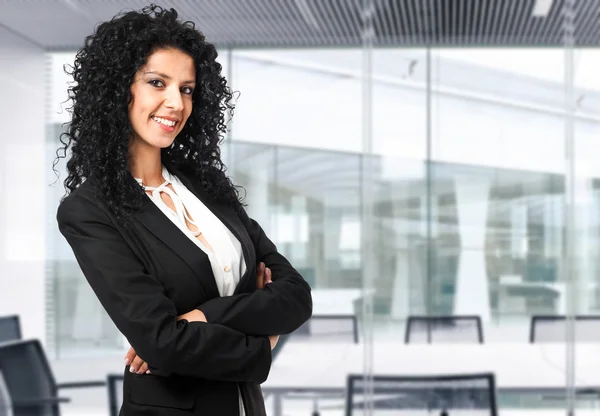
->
<box><xmin>0</xmin><ymin>0</ymin><xmax>600</xmax><ymax>50</ymax></box>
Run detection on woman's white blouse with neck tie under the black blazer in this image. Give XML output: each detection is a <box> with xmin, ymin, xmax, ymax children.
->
<box><xmin>135</xmin><ymin>166</ymin><xmax>246</xmax><ymax>416</ymax></box>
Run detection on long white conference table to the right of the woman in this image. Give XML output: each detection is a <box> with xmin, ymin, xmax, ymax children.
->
<box><xmin>262</xmin><ymin>339</ymin><xmax>600</xmax><ymax>416</ymax></box>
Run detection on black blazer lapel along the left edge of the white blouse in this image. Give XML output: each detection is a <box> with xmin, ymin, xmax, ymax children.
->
<box><xmin>131</xmin><ymin>172</ymin><xmax>219</xmax><ymax>298</ymax></box>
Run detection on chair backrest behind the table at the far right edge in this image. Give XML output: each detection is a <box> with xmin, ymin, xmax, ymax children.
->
<box><xmin>529</xmin><ymin>315</ymin><xmax>600</xmax><ymax>343</ymax></box>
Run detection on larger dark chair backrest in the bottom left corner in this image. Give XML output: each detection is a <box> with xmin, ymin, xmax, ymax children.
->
<box><xmin>0</xmin><ymin>339</ymin><xmax>60</xmax><ymax>416</ymax></box>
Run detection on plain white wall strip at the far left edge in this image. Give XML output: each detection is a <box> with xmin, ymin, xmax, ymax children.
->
<box><xmin>0</xmin><ymin>27</ymin><xmax>50</xmax><ymax>341</ymax></box>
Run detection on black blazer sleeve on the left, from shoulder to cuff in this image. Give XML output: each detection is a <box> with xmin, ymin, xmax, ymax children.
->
<box><xmin>57</xmin><ymin>195</ymin><xmax>271</xmax><ymax>383</ymax></box>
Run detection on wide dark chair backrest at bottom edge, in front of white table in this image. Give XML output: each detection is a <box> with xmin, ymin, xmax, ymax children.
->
<box><xmin>346</xmin><ymin>373</ymin><xmax>498</xmax><ymax>416</ymax></box>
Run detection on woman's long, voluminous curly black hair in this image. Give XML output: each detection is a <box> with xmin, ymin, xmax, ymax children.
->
<box><xmin>53</xmin><ymin>4</ymin><xmax>241</xmax><ymax>222</ymax></box>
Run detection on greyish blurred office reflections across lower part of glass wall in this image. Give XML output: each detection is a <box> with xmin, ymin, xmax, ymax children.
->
<box><xmin>49</xmin><ymin>136</ymin><xmax>600</xmax><ymax>354</ymax></box>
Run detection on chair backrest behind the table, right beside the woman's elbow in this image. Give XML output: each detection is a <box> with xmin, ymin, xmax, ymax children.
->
<box><xmin>291</xmin><ymin>315</ymin><xmax>358</xmax><ymax>344</ymax></box>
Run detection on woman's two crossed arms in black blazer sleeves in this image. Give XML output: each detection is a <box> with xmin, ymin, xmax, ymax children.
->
<box><xmin>57</xmin><ymin>195</ymin><xmax>312</xmax><ymax>383</ymax></box>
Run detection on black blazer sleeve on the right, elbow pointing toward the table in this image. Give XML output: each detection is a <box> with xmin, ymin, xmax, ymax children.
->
<box><xmin>198</xmin><ymin>206</ymin><xmax>312</xmax><ymax>335</ymax></box>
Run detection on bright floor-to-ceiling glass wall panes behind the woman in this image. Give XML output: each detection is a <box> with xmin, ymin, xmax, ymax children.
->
<box><xmin>46</xmin><ymin>44</ymin><xmax>600</xmax><ymax>353</ymax></box>
